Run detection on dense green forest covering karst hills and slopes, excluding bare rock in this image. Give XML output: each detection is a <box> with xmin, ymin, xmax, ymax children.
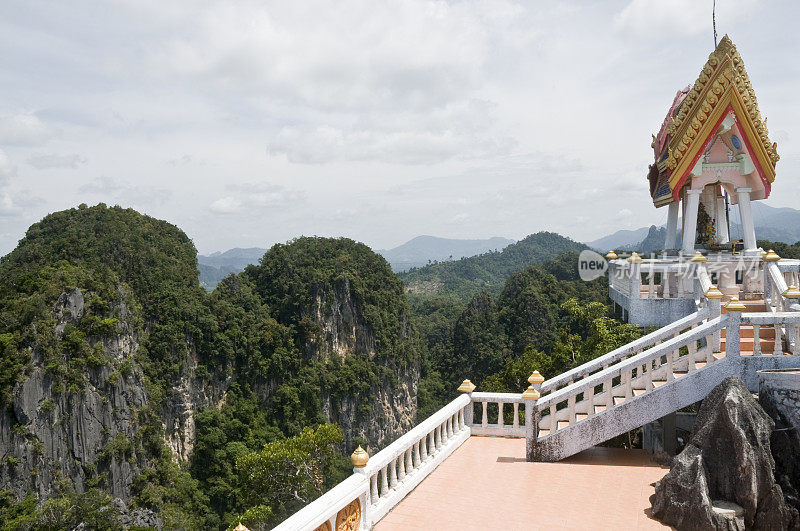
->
<box><xmin>0</xmin><ymin>204</ymin><xmax>644</xmax><ymax>529</ymax></box>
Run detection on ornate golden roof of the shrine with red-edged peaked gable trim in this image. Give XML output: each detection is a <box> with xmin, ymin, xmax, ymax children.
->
<box><xmin>650</xmin><ymin>35</ymin><xmax>780</xmax><ymax>206</ymax></box>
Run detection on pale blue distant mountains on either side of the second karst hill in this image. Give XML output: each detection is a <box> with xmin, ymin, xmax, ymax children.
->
<box><xmin>197</xmin><ymin>236</ymin><xmax>514</xmax><ymax>290</ymax></box>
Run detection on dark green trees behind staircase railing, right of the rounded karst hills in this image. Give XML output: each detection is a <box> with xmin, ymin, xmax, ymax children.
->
<box><xmin>411</xmin><ymin>252</ymin><xmax>641</xmax><ymax>416</ymax></box>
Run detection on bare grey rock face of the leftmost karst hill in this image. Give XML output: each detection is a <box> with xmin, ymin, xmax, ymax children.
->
<box><xmin>0</xmin><ymin>288</ymin><xmax>147</xmax><ymax>500</ymax></box>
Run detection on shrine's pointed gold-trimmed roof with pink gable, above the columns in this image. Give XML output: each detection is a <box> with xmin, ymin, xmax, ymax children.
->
<box><xmin>648</xmin><ymin>35</ymin><xmax>780</xmax><ymax>207</ymax></box>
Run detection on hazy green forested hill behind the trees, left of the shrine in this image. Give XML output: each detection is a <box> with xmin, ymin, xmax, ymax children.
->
<box><xmin>400</xmin><ymin>232</ymin><xmax>588</xmax><ymax>301</ymax></box>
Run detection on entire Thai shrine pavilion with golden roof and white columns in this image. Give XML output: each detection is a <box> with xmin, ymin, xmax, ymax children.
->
<box><xmin>647</xmin><ymin>35</ymin><xmax>780</xmax><ymax>254</ymax></box>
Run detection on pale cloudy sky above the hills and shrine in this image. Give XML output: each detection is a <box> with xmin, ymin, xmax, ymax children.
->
<box><xmin>0</xmin><ymin>0</ymin><xmax>800</xmax><ymax>255</ymax></box>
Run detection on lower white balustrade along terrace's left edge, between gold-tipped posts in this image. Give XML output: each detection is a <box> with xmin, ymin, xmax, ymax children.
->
<box><xmin>355</xmin><ymin>394</ymin><xmax>471</xmax><ymax>527</ymax></box>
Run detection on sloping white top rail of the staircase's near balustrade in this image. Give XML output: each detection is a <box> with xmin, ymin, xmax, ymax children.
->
<box><xmin>536</xmin><ymin>314</ymin><xmax>729</xmax><ymax>410</ymax></box>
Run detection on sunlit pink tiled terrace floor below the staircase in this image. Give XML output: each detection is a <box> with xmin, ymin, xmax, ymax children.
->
<box><xmin>375</xmin><ymin>437</ymin><xmax>668</xmax><ymax>531</ymax></box>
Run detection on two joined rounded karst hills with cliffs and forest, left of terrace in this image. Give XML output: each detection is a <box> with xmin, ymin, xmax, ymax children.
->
<box><xmin>0</xmin><ymin>204</ymin><xmax>420</xmax><ymax>529</ymax></box>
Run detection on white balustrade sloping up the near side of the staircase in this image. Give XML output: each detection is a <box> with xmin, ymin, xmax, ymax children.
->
<box><xmin>536</xmin><ymin>315</ymin><xmax>734</xmax><ymax>440</ymax></box>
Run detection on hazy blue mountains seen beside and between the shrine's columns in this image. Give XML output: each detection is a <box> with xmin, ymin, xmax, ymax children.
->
<box><xmin>586</xmin><ymin>201</ymin><xmax>800</xmax><ymax>253</ymax></box>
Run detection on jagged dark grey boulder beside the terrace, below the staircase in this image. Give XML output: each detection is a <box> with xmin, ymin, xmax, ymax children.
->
<box><xmin>651</xmin><ymin>377</ymin><xmax>800</xmax><ymax>530</ymax></box>
